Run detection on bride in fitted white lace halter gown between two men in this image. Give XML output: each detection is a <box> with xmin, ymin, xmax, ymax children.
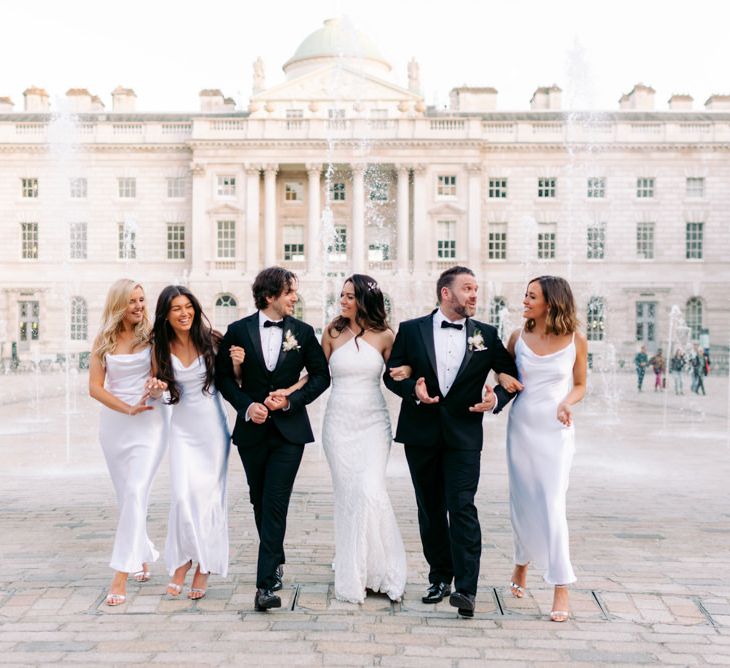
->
<box><xmin>322</xmin><ymin>274</ymin><xmax>408</xmax><ymax>603</ymax></box>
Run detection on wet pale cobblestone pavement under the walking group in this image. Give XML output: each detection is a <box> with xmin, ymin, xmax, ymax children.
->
<box><xmin>0</xmin><ymin>374</ymin><xmax>730</xmax><ymax>668</ymax></box>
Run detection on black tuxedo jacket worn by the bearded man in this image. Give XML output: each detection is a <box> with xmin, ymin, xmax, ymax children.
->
<box><xmin>383</xmin><ymin>311</ymin><xmax>517</xmax><ymax>450</ymax></box>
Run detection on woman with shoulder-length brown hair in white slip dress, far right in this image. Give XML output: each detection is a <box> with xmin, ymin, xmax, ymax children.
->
<box><xmin>500</xmin><ymin>276</ymin><xmax>588</xmax><ymax>622</ymax></box>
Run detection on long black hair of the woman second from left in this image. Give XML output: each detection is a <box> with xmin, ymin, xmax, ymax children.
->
<box><xmin>152</xmin><ymin>285</ymin><xmax>220</xmax><ymax>404</ymax></box>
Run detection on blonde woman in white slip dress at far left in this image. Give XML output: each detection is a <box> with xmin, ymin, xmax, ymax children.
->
<box><xmin>89</xmin><ymin>279</ymin><xmax>167</xmax><ymax>605</ymax></box>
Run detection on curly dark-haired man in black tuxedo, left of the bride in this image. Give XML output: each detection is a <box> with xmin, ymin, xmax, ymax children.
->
<box><xmin>215</xmin><ymin>267</ymin><xmax>330</xmax><ymax>610</ymax></box>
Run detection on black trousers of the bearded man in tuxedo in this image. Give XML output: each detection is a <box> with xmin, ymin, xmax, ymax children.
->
<box><xmin>405</xmin><ymin>442</ymin><xmax>482</xmax><ymax>595</ymax></box>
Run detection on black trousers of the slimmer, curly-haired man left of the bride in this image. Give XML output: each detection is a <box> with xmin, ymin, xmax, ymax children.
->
<box><xmin>238</xmin><ymin>424</ymin><xmax>304</xmax><ymax>589</ymax></box>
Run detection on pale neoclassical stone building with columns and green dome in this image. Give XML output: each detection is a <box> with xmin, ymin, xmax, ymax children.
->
<box><xmin>0</xmin><ymin>19</ymin><xmax>730</xmax><ymax>361</ymax></box>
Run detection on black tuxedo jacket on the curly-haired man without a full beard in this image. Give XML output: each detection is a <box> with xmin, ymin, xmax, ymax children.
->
<box><xmin>215</xmin><ymin>311</ymin><xmax>330</xmax><ymax>448</ymax></box>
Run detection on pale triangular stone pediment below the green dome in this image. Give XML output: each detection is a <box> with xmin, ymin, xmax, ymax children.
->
<box><xmin>251</xmin><ymin>65</ymin><xmax>422</xmax><ymax>103</ymax></box>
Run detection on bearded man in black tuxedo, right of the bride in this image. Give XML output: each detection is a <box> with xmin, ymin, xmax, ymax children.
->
<box><xmin>383</xmin><ymin>267</ymin><xmax>517</xmax><ymax>617</ymax></box>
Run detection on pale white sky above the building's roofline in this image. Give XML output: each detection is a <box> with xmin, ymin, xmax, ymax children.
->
<box><xmin>0</xmin><ymin>0</ymin><xmax>730</xmax><ymax>111</ymax></box>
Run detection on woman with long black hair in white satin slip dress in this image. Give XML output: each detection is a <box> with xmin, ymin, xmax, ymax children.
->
<box><xmin>154</xmin><ymin>285</ymin><xmax>230</xmax><ymax>600</ymax></box>
